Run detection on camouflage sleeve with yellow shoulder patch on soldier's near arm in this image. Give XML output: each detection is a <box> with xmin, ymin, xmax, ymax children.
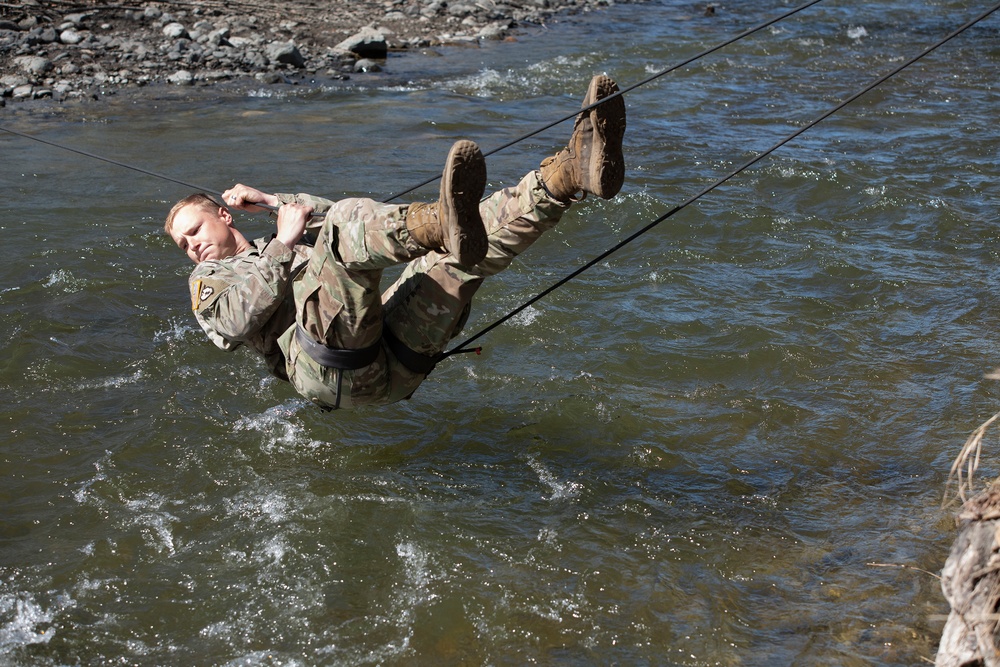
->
<box><xmin>189</xmin><ymin>239</ymin><xmax>295</xmax><ymax>350</ymax></box>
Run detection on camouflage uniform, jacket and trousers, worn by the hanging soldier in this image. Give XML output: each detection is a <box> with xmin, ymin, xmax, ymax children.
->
<box><xmin>190</xmin><ymin>172</ymin><xmax>569</xmax><ymax>408</ymax></box>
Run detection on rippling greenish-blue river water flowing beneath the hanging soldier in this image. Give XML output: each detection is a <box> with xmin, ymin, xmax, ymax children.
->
<box><xmin>0</xmin><ymin>0</ymin><xmax>1000</xmax><ymax>666</ymax></box>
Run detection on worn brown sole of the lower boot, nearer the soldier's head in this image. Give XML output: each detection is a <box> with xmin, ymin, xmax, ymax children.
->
<box><xmin>440</xmin><ymin>140</ymin><xmax>487</xmax><ymax>266</ymax></box>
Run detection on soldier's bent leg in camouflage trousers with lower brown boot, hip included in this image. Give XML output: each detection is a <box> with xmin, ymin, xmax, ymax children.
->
<box><xmin>280</xmin><ymin>141</ymin><xmax>486</xmax><ymax>407</ymax></box>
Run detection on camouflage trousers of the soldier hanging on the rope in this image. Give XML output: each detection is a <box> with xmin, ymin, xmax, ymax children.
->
<box><xmin>279</xmin><ymin>171</ymin><xmax>569</xmax><ymax>408</ymax></box>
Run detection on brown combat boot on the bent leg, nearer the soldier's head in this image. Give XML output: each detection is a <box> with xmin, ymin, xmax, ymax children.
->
<box><xmin>406</xmin><ymin>140</ymin><xmax>486</xmax><ymax>266</ymax></box>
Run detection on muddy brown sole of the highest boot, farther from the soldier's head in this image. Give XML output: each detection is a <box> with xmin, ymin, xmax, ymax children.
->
<box><xmin>583</xmin><ymin>74</ymin><xmax>625</xmax><ymax>199</ymax></box>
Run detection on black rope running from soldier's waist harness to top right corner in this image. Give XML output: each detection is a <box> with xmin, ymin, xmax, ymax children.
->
<box><xmin>442</xmin><ymin>3</ymin><xmax>1000</xmax><ymax>358</ymax></box>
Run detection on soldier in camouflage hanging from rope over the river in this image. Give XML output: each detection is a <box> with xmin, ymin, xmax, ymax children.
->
<box><xmin>165</xmin><ymin>75</ymin><xmax>625</xmax><ymax>409</ymax></box>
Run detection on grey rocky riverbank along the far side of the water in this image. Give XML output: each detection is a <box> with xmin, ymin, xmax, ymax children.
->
<box><xmin>0</xmin><ymin>0</ymin><xmax>632</xmax><ymax>106</ymax></box>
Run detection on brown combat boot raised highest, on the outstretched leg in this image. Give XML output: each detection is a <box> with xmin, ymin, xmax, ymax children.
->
<box><xmin>541</xmin><ymin>74</ymin><xmax>625</xmax><ymax>202</ymax></box>
